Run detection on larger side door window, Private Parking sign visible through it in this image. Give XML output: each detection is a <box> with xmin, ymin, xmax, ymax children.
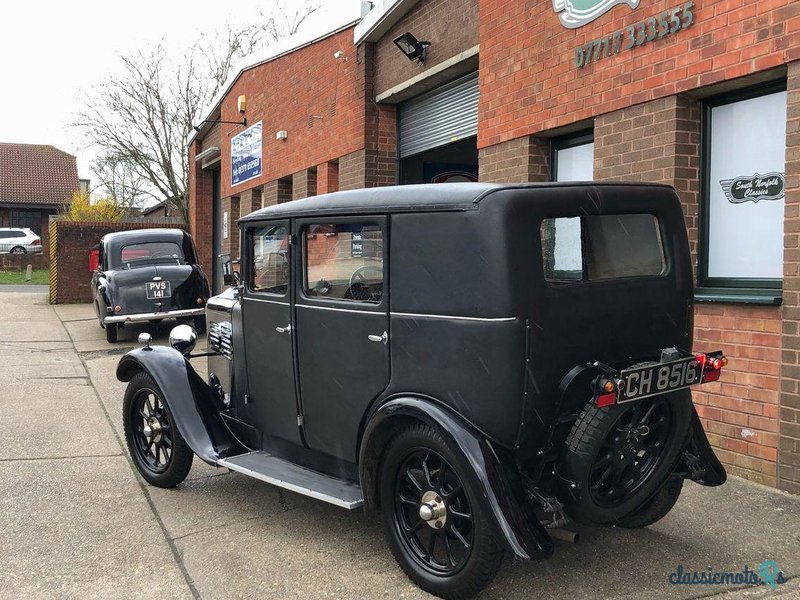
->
<box><xmin>303</xmin><ymin>221</ymin><xmax>384</xmax><ymax>304</ymax></box>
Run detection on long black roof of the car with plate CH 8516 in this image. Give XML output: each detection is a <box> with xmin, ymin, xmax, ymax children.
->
<box><xmin>239</xmin><ymin>181</ymin><xmax>671</xmax><ymax>222</ymax></box>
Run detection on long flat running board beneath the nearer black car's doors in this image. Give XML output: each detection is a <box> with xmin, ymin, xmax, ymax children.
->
<box><xmin>217</xmin><ymin>452</ymin><xmax>364</xmax><ymax>510</ymax></box>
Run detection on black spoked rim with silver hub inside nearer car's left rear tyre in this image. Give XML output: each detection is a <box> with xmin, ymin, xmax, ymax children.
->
<box><xmin>394</xmin><ymin>448</ymin><xmax>474</xmax><ymax>576</ymax></box>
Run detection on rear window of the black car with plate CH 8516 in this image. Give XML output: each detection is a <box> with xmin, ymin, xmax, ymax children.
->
<box><xmin>541</xmin><ymin>214</ymin><xmax>666</xmax><ymax>283</ymax></box>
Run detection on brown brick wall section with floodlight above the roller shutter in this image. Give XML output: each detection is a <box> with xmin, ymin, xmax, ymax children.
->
<box><xmin>375</xmin><ymin>0</ymin><xmax>478</xmax><ymax>95</ymax></box>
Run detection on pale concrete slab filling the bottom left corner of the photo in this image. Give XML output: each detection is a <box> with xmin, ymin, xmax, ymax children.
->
<box><xmin>0</xmin><ymin>456</ymin><xmax>192</xmax><ymax>600</ymax></box>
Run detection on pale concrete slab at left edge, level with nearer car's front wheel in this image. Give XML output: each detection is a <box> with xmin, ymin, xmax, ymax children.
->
<box><xmin>0</xmin><ymin>378</ymin><xmax>122</xmax><ymax>460</ymax></box>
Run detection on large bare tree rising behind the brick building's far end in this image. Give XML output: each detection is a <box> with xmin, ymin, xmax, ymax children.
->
<box><xmin>74</xmin><ymin>0</ymin><xmax>319</xmax><ymax>219</ymax></box>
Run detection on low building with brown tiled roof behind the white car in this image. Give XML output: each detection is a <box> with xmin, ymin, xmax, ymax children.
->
<box><xmin>0</xmin><ymin>143</ymin><xmax>79</xmax><ymax>255</ymax></box>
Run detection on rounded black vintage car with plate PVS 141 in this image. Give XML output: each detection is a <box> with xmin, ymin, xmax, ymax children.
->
<box><xmin>91</xmin><ymin>229</ymin><xmax>209</xmax><ymax>342</ymax></box>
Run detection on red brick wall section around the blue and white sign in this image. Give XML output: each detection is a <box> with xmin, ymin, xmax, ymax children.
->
<box><xmin>218</xmin><ymin>28</ymin><xmax>366</xmax><ymax>198</ymax></box>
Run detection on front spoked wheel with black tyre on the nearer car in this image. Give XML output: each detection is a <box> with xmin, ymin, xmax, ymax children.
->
<box><xmin>122</xmin><ymin>372</ymin><xmax>194</xmax><ymax>488</ymax></box>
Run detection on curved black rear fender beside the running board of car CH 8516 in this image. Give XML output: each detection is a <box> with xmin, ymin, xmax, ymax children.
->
<box><xmin>359</xmin><ymin>398</ymin><xmax>553</xmax><ymax>560</ymax></box>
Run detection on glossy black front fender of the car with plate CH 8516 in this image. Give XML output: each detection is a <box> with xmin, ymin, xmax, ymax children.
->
<box><xmin>117</xmin><ymin>346</ymin><xmax>244</xmax><ymax>464</ymax></box>
